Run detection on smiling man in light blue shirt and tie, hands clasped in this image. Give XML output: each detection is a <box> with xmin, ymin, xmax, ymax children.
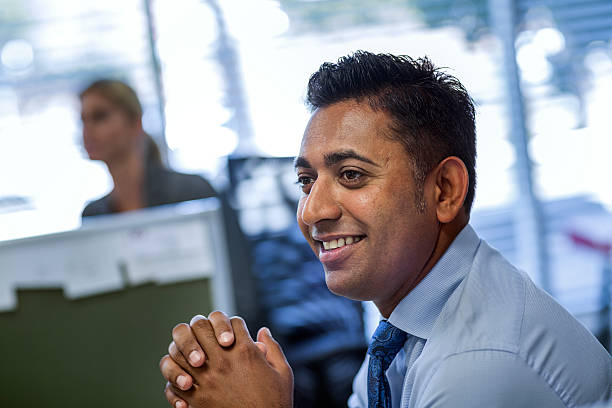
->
<box><xmin>160</xmin><ymin>52</ymin><xmax>612</xmax><ymax>408</ymax></box>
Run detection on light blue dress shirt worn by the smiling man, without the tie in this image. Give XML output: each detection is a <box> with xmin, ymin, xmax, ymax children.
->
<box><xmin>348</xmin><ymin>225</ymin><xmax>612</xmax><ymax>408</ymax></box>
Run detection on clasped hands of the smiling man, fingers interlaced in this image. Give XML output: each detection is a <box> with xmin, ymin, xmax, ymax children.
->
<box><xmin>159</xmin><ymin>311</ymin><xmax>293</xmax><ymax>408</ymax></box>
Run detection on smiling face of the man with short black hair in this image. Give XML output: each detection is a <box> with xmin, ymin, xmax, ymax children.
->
<box><xmin>296</xmin><ymin>101</ymin><xmax>439</xmax><ymax>302</ymax></box>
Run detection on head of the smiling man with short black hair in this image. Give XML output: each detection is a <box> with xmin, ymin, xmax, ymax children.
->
<box><xmin>296</xmin><ymin>52</ymin><xmax>476</xmax><ymax>312</ymax></box>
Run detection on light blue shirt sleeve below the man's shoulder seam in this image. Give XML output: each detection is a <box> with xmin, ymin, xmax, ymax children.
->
<box><xmin>416</xmin><ymin>350</ymin><xmax>567</xmax><ymax>408</ymax></box>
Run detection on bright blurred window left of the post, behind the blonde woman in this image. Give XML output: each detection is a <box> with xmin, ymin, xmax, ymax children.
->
<box><xmin>0</xmin><ymin>0</ymin><xmax>162</xmax><ymax>240</ymax></box>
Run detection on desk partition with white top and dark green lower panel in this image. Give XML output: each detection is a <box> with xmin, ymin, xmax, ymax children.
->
<box><xmin>0</xmin><ymin>199</ymin><xmax>235</xmax><ymax>408</ymax></box>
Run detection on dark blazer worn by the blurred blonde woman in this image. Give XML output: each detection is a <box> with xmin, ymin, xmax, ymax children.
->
<box><xmin>82</xmin><ymin>164</ymin><xmax>217</xmax><ymax>217</ymax></box>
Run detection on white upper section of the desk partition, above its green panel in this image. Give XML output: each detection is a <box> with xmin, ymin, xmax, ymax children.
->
<box><xmin>0</xmin><ymin>198</ymin><xmax>236</xmax><ymax>315</ymax></box>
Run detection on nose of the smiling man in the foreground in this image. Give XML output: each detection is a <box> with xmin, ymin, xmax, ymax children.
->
<box><xmin>300</xmin><ymin>178</ymin><xmax>342</xmax><ymax>226</ymax></box>
